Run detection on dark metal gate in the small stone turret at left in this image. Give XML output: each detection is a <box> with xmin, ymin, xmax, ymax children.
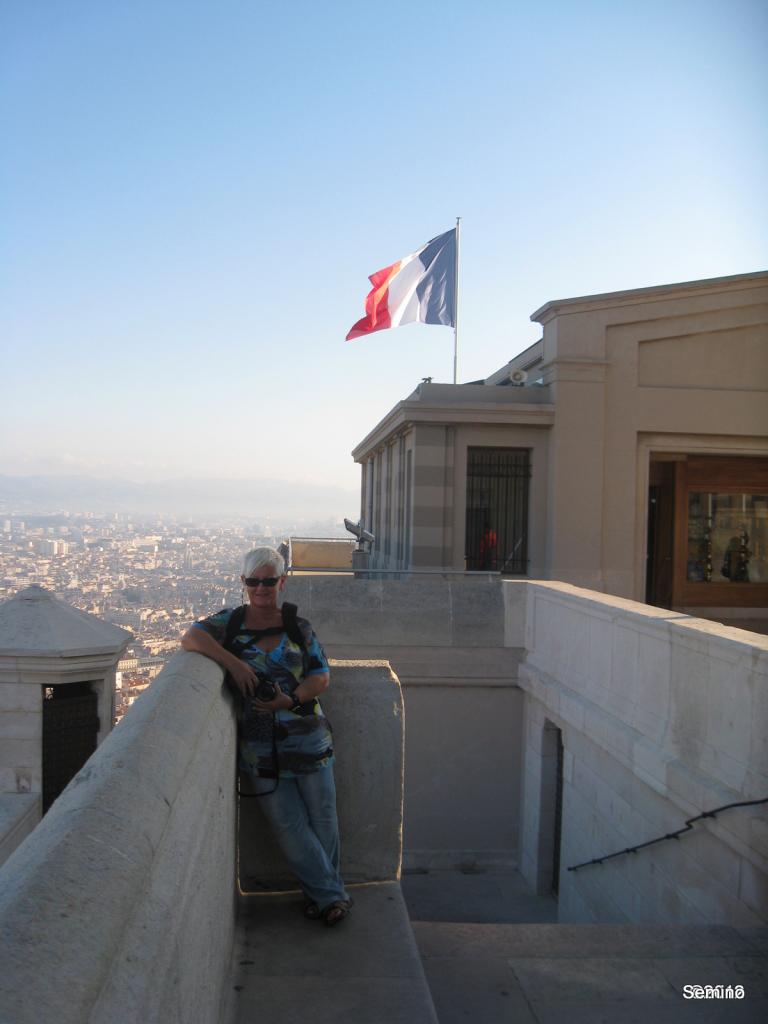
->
<box><xmin>43</xmin><ymin>683</ymin><xmax>98</xmax><ymax>814</ymax></box>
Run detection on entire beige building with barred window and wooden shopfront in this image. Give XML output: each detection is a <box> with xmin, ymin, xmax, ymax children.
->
<box><xmin>353</xmin><ymin>271</ymin><xmax>768</xmax><ymax>620</ymax></box>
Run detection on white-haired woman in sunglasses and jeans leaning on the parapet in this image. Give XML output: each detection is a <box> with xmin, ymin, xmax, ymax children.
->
<box><xmin>181</xmin><ymin>548</ymin><xmax>351</xmax><ymax>925</ymax></box>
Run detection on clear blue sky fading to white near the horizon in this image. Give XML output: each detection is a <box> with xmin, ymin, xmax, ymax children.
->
<box><xmin>0</xmin><ymin>0</ymin><xmax>768</xmax><ymax>495</ymax></box>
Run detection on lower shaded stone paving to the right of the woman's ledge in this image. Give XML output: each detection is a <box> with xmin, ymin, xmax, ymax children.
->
<box><xmin>402</xmin><ymin>871</ymin><xmax>768</xmax><ymax>1024</ymax></box>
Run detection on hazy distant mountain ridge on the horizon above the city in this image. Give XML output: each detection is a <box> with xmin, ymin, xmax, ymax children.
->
<box><xmin>0</xmin><ymin>474</ymin><xmax>359</xmax><ymax>519</ymax></box>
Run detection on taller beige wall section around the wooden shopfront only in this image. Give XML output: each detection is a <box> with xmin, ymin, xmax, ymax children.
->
<box><xmin>544</xmin><ymin>283</ymin><xmax>768</xmax><ymax>600</ymax></box>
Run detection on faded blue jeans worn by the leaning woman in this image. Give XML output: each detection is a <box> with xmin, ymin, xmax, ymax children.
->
<box><xmin>253</xmin><ymin>765</ymin><xmax>349</xmax><ymax>909</ymax></box>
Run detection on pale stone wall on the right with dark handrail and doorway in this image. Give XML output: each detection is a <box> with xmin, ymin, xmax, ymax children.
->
<box><xmin>518</xmin><ymin>583</ymin><xmax>768</xmax><ymax>926</ymax></box>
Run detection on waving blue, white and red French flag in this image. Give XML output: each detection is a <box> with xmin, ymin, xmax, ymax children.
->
<box><xmin>346</xmin><ymin>227</ymin><xmax>457</xmax><ymax>341</ymax></box>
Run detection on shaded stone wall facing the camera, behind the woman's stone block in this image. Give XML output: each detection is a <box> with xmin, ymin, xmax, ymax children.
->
<box><xmin>286</xmin><ymin>575</ymin><xmax>525</xmax><ymax>868</ymax></box>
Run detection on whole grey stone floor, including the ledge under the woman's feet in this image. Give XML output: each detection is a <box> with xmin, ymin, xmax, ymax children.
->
<box><xmin>222</xmin><ymin>870</ymin><xmax>768</xmax><ymax>1024</ymax></box>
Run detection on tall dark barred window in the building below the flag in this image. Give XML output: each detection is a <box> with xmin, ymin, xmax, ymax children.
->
<box><xmin>465</xmin><ymin>447</ymin><xmax>530</xmax><ymax>573</ymax></box>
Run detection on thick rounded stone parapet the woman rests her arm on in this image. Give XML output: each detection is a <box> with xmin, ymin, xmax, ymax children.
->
<box><xmin>0</xmin><ymin>653</ymin><xmax>236</xmax><ymax>1024</ymax></box>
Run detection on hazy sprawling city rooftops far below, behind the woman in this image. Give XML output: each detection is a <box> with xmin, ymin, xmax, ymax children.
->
<box><xmin>0</xmin><ymin>509</ymin><xmax>348</xmax><ymax>719</ymax></box>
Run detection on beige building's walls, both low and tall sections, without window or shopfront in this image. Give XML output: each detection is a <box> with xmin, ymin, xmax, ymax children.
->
<box><xmin>355</xmin><ymin>275</ymin><xmax>768</xmax><ymax>600</ymax></box>
